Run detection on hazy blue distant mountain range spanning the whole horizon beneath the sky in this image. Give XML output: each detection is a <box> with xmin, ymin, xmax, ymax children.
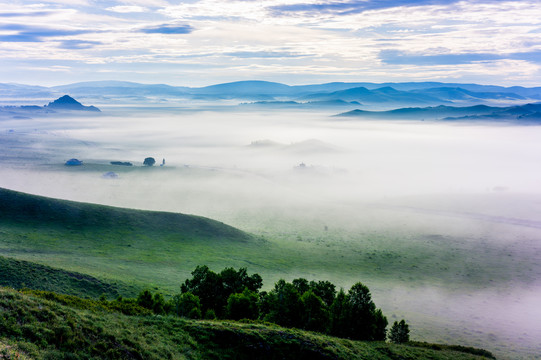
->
<box><xmin>0</xmin><ymin>81</ymin><xmax>541</xmax><ymax>109</ymax></box>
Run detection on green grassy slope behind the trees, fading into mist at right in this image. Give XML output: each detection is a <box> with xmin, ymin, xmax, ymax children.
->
<box><xmin>0</xmin><ymin>186</ymin><xmax>522</xmax><ymax>294</ymax></box>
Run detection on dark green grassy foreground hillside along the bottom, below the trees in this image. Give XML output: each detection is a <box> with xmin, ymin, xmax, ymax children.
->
<box><xmin>0</xmin><ymin>289</ymin><xmax>491</xmax><ymax>360</ymax></box>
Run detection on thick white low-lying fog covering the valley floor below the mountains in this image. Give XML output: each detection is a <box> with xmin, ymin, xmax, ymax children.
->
<box><xmin>0</xmin><ymin>108</ymin><xmax>541</xmax><ymax>358</ymax></box>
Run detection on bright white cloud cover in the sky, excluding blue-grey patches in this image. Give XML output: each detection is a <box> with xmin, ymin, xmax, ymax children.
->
<box><xmin>0</xmin><ymin>0</ymin><xmax>541</xmax><ymax>82</ymax></box>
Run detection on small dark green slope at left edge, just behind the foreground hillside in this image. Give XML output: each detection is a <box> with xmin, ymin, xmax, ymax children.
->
<box><xmin>0</xmin><ymin>256</ymin><xmax>139</xmax><ymax>299</ymax></box>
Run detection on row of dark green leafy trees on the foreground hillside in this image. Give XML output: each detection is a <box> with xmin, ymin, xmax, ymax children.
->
<box><xmin>136</xmin><ymin>265</ymin><xmax>409</xmax><ymax>343</ymax></box>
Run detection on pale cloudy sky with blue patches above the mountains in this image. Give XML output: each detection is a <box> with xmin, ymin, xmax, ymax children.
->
<box><xmin>0</xmin><ymin>0</ymin><xmax>541</xmax><ymax>86</ymax></box>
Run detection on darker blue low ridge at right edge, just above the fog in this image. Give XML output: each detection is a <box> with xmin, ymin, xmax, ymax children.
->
<box><xmin>335</xmin><ymin>103</ymin><xmax>541</xmax><ymax>122</ymax></box>
